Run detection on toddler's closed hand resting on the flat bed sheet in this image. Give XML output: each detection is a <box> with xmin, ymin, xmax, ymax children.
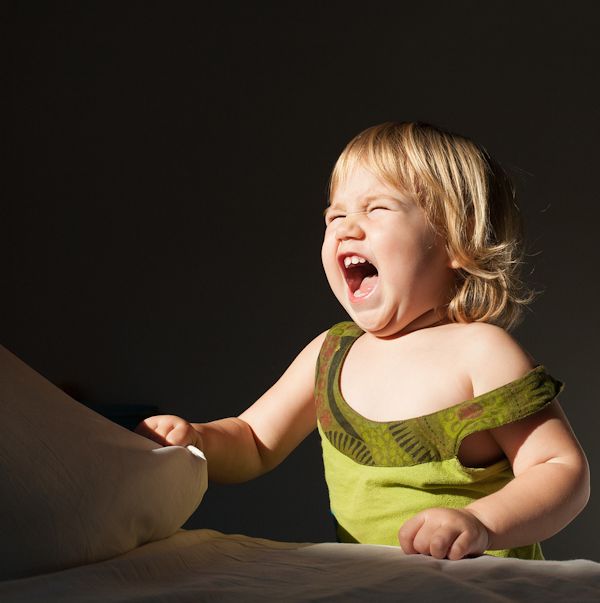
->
<box><xmin>398</xmin><ymin>508</ymin><xmax>490</xmax><ymax>559</ymax></box>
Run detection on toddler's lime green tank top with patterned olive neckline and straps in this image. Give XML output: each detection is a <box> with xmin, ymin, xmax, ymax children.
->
<box><xmin>315</xmin><ymin>322</ymin><xmax>563</xmax><ymax>559</ymax></box>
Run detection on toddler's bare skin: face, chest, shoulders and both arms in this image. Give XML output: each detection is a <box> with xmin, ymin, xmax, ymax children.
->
<box><xmin>136</xmin><ymin>167</ymin><xmax>589</xmax><ymax>559</ymax></box>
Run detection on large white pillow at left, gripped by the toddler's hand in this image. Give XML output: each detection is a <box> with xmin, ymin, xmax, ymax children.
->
<box><xmin>0</xmin><ymin>346</ymin><xmax>208</xmax><ymax>580</ymax></box>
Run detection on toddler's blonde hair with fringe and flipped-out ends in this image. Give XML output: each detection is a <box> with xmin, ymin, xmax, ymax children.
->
<box><xmin>329</xmin><ymin>122</ymin><xmax>534</xmax><ymax>329</ymax></box>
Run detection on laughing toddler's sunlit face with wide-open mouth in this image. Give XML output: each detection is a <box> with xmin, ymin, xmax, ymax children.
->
<box><xmin>322</xmin><ymin>164</ymin><xmax>454</xmax><ymax>337</ymax></box>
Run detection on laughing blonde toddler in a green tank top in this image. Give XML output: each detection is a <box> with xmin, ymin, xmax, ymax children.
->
<box><xmin>136</xmin><ymin>123</ymin><xmax>589</xmax><ymax>559</ymax></box>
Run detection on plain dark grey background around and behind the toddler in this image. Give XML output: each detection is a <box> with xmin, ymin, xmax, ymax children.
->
<box><xmin>0</xmin><ymin>1</ymin><xmax>600</xmax><ymax>561</ymax></box>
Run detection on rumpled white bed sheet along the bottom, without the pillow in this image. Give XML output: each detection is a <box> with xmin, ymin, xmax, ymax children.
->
<box><xmin>0</xmin><ymin>530</ymin><xmax>600</xmax><ymax>603</ymax></box>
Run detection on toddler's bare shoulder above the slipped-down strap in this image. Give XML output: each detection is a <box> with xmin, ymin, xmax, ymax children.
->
<box><xmin>448</xmin><ymin>322</ymin><xmax>536</xmax><ymax>396</ymax></box>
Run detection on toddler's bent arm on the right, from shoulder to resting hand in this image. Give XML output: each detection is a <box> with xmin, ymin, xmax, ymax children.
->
<box><xmin>399</xmin><ymin>332</ymin><xmax>590</xmax><ymax>559</ymax></box>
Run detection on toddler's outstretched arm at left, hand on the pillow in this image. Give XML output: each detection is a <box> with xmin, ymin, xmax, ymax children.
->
<box><xmin>136</xmin><ymin>333</ymin><xmax>326</xmax><ymax>483</ymax></box>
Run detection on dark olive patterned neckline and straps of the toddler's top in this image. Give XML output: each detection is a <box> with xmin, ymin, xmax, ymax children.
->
<box><xmin>315</xmin><ymin>322</ymin><xmax>564</xmax><ymax>467</ymax></box>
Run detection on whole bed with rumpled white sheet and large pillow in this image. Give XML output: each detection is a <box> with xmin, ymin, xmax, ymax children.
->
<box><xmin>0</xmin><ymin>347</ymin><xmax>600</xmax><ymax>603</ymax></box>
